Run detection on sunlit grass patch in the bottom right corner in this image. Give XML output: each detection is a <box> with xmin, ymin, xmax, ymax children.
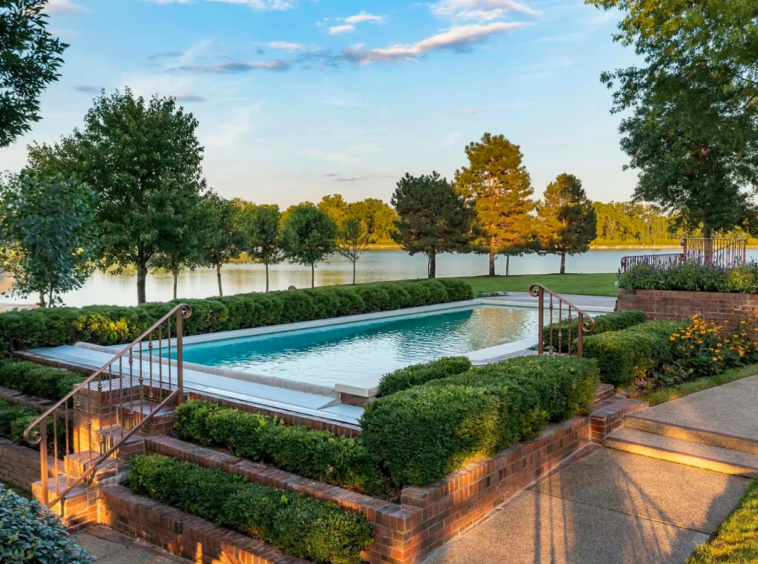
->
<box><xmin>687</xmin><ymin>480</ymin><xmax>758</xmax><ymax>564</ymax></box>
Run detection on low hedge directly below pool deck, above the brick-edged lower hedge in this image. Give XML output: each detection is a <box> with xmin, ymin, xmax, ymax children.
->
<box><xmin>174</xmin><ymin>401</ymin><xmax>390</xmax><ymax>496</ymax></box>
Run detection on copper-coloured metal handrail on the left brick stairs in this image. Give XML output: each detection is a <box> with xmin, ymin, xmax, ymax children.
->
<box><xmin>24</xmin><ymin>304</ymin><xmax>192</xmax><ymax>507</ymax></box>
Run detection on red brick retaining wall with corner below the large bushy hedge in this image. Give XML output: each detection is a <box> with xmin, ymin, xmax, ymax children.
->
<box><xmin>145</xmin><ymin>417</ymin><xmax>590</xmax><ymax>564</ymax></box>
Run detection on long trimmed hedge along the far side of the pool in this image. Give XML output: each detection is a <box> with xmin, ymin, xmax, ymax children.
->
<box><xmin>0</xmin><ymin>279</ymin><xmax>473</xmax><ymax>352</ymax></box>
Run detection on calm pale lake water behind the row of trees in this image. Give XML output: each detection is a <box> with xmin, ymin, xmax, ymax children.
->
<box><xmin>0</xmin><ymin>249</ymin><xmax>758</xmax><ymax>307</ymax></box>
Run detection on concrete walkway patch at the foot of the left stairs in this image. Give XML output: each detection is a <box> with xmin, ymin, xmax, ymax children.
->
<box><xmin>72</xmin><ymin>525</ymin><xmax>189</xmax><ymax>564</ymax></box>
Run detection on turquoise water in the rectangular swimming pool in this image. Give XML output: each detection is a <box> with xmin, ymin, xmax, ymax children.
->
<box><xmin>168</xmin><ymin>306</ymin><xmax>538</xmax><ymax>385</ymax></box>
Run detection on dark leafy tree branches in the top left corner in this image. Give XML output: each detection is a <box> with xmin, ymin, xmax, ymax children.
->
<box><xmin>0</xmin><ymin>0</ymin><xmax>68</xmax><ymax>147</ymax></box>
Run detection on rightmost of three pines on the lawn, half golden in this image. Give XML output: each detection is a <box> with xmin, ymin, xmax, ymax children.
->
<box><xmin>537</xmin><ymin>174</ymin><xmax>597</xmax><ymax>274</ymax></box>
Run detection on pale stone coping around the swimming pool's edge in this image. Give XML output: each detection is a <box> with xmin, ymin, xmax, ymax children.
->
<box><xmin>81</xmin><ymin>296</ymin><xmax>613</xmax><ymax>401</ymax></box>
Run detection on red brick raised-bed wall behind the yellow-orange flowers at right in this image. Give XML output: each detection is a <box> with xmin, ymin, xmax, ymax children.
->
<box><xmin>616</xmin><ymin>288</ymin><xmax>758</xmax><ymax>322</ymax></box>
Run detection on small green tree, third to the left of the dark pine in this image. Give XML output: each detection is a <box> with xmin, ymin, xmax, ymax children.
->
<box><xmin>243</xmin><ymin>205</ymin><xmax>284</xmax><ymax>292</ymax></box>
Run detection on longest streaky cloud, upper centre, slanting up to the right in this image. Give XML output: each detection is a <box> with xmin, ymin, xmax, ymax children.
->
<box><xmin>343</xmin><ymin>22</ymin><xmax>526</xmax><ymax>65</ymax></box>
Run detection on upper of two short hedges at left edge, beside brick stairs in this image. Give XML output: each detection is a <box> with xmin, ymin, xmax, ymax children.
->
<box><xmin>0</xmin><ymin>358</ymin><xmax>84</xmax><ymax>401</ymax></box>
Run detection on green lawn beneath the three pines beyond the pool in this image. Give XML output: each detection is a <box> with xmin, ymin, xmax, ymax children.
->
<box><xmin>452</xmin><ymin>274</ymin><xmax>616</xmax><ymax>296</ymax></box>
